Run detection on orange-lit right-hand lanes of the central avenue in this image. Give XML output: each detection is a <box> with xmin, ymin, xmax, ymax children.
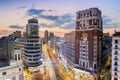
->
<box><xmin>45</xmin><ymin>45</ymin><xmax>74</xmax><ymax>80</ymax></box>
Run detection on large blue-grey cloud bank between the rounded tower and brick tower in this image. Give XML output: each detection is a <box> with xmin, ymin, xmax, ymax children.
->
<box><xmin>26</xmin><ymin>9</ymin><xmax>75</xmax><ymax>29</ymax></box>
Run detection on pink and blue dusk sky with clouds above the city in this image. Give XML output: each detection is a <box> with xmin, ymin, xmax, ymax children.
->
<box><xmin>0</xmin><ymin>0</ymin><xmax>120</xmax><ymax>36</ymax></box>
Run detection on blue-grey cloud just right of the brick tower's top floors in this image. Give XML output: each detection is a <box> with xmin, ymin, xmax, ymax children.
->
<box><xmin>102</xmin><ymin>15</ymin><xmax>119</xmax><ymax>29</ymax></box>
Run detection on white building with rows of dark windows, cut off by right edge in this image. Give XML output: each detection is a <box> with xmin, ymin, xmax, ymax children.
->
<box><xmin>111</xmin><ymin>32</ymin><xmax>120</xmax><ymax>80</ymax></box>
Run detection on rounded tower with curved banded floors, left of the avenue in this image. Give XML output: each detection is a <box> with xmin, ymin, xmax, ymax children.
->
<box><xmin>24</xmin><ymin>19</ymin><xmax>42</xmax><ymax>72</ymax></box>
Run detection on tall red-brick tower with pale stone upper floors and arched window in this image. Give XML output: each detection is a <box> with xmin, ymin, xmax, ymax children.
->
<box><xmin>75</xmin><ymin>8</ymin><xmax>102</xmax><ymax>72</ymax></box>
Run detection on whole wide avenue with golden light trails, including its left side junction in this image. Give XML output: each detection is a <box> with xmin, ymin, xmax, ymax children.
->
<box><xmin>24</xmin><ymin>45</ymin><xmax>74</xmax><ymax>80</ymax></box>
